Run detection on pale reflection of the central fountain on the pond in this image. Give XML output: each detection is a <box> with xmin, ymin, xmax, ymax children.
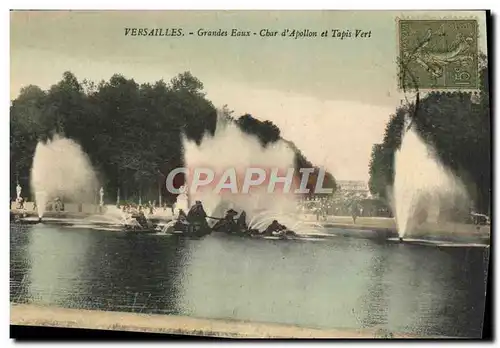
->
<box><xmin>182</xmin><ymin>238</ymin><xmax>382</xmax><ymax>328</ymax></box>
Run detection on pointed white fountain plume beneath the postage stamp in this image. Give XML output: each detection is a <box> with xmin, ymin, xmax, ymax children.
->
<box><xmin>390</xmin><ymin>118</ymin><xmax>468</xmax><ymax>241</ymax></box>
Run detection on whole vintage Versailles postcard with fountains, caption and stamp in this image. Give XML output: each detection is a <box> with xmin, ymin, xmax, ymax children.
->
<box><xmin>10</xmin><ymin>10</ymin><xmax>492</xmax><ymax>339</ymax></box>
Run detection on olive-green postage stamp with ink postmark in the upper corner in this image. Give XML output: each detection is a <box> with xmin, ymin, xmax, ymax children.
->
<box><xmin>398</xmin><ymin>19</ymin><xmax>479</xmax><ymax>89</ymax></box>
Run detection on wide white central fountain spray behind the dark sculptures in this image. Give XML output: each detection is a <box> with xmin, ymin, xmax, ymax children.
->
<box><xmin>183</xmin><ymin>109</ymin><xmax>324</xmax><ymax>233</ymax></box>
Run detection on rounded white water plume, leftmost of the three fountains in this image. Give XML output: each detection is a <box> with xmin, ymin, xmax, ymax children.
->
<box><xmin>31</xmin><ymin>135</ymin><xmax>98</xmax><ymax>217</ymax></box>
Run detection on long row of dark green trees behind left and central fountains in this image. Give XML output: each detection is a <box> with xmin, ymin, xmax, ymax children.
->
<box><xmin>10</xmin><ymin>72</ymin><xmax>335</xmax><ymax>207</ymax></box>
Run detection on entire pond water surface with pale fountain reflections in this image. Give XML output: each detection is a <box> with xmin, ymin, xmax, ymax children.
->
<box><xmin>10</xmin><ymin>225</ymin><xmax>487</xmax><ymax>337</ymax></box>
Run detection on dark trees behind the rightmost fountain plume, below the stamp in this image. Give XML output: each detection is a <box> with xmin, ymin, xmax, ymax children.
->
<box><xmin>369</xmin><ymin>57</ymin><xmax>491</xmax><ymax>213</ymax></box>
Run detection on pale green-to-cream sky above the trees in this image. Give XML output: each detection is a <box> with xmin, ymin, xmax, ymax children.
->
<box><xmin>10</xmin><ymin>11</ymin><xmax>486</xmax><ymax>181</ymax></box>
